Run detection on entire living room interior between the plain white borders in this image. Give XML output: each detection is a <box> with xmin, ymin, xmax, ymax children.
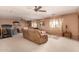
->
<box><xmin>0</xmin><ymin>6</ymin><xmax>79</xmax><ymax>52</ymax></box>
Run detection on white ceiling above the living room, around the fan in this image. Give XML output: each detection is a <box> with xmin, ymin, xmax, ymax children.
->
<box><xmin>0</xmin><ymin>6</ymin><xmax>79</xmax><ymax>20</ymax></box>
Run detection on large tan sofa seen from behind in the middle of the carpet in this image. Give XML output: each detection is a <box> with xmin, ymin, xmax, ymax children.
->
<box><xmin>22</xmin><ymin>29</ymin><xmax>48</xmax><ymax>44</ymax></box>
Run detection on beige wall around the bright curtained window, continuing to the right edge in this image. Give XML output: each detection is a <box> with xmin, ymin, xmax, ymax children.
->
<box><xmin>32</xmin><ymin>13</ymin><xmax>79</xmax><ymax>39</ymax></box>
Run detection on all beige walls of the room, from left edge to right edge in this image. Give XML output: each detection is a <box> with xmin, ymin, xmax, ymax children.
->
<box><xmin>0</xmin><ymin>14</ymin><xmax>79</xmax><ymax>39</ymax></box>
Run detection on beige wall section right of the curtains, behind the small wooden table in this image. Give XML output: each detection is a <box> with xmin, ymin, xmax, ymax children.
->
<box><xmin>63</xmin><ymin>14</ymin><xmax>79</xmax><ymax>39</ymax></box>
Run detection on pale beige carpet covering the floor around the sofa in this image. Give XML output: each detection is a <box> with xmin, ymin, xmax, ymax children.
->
<box><xmin>0</xmin><ymin>33</ymin><xmax>79</xmax><ymax>52</ymax></box>
